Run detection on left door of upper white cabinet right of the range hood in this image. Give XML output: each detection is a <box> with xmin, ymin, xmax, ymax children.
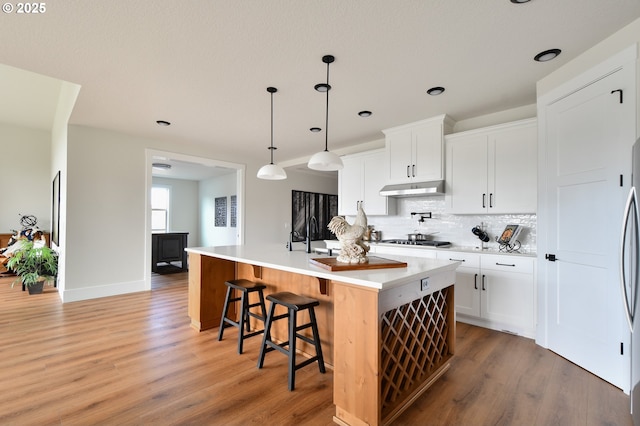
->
<box><xmin>447</xmin><ymin>135</ymin><xmax>489</xmax><ymax>214</ymax></box>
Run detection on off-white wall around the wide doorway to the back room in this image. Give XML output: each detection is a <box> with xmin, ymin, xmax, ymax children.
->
<box><xmin>62</xmin><ymin>126</ymin><xmax>337</xmax><ymax>302</ymax></box>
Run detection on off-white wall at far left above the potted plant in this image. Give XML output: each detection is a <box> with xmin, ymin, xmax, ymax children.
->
<box><xmin>0</xmin><ymin>123</ymin><xmax>52</xmax><ymax>233</ymax></box>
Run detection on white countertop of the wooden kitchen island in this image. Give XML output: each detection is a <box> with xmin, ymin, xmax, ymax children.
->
<box><xmin>186</xmin><ymin>245</ymin><xmax>460</xmax><ymax>290</ymax></box>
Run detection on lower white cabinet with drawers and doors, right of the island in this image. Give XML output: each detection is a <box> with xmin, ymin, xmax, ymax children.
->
<box><xmin>437</xmin><ymin>251</ymin><xmax>536</xmax><ymax>338</ymax></box>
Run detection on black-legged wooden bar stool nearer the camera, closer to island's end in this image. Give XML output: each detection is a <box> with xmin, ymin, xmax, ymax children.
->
<box><xmin>258</xmin><ymin>291</ymin><xmax>325</xmax><ymax>391</ymax></box>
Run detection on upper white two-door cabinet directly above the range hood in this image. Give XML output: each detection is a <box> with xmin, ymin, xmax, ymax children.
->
<box><xmin>383</xmin><ymin>115</ymin><xmax>453</xmax><ymax>184</ymax></box>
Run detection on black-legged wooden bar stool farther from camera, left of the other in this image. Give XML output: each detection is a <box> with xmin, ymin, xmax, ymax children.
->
<box><xmin>218</xmin><ymin>279</ymin><xmax>267</xmax><ymax>354</ymax></box>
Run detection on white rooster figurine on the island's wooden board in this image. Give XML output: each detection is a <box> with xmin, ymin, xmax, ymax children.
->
<box><xmin>327</xmin><ymin>204</ymin><xmax>369</xmax><ymax>263</ymax></box>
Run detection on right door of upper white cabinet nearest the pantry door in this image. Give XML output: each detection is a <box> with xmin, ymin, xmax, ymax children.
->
<box><xmin>488</xmin><ymin>122</ymin><xmax>538</xmax><ymax>213</ymax></box>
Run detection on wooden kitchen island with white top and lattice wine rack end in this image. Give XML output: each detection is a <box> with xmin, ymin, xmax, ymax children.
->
<box><xmin>187</xmin><ymin>246</ymin><xmax>459</xmax><ymax>425</ymax></box>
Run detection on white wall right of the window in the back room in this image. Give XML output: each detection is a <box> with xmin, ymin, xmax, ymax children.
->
<box><xmin>153</xmin><ymin>177</ymin><xmax>200</xmax><ymax>247</ymax></box>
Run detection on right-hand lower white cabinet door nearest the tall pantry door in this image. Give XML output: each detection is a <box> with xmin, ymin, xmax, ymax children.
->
<box><xmin>480</xmin><ymin>269</ymin><xmax>535</xmax><ymax>334</ymax></box>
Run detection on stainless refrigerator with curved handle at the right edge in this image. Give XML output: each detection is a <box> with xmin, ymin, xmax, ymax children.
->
<box><xmin>620</xmin><ymin>139</ymin><xmax>640</xmax><ymax>426</ymax></box>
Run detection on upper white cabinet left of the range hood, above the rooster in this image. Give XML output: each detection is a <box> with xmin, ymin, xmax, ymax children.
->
<box><xmin>338</xmin><ymin>149</ymin><xmax>396</xmax><ymax>216</ymax></box>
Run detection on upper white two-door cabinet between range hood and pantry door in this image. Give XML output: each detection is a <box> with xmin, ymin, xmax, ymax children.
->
<box><xmin>445</xmin><ymin>119</ymin><xmax>537</xmax><ymax>214</ymax></box>
